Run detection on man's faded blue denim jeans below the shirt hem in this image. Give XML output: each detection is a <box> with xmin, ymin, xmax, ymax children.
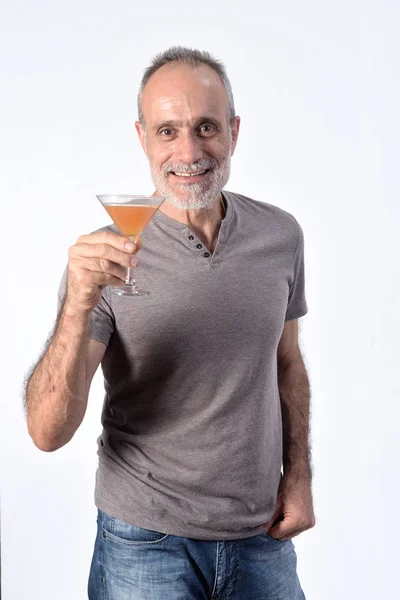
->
<box><xmin>88</xmin><ymin>510</ymin><xmax>305</xmax><ymax>600</ymax></box>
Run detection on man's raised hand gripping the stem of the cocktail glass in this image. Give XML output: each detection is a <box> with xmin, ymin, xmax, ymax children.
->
<box><xmin>66</xmin><ymin>231</ymin><xmax>141</xmax><ymax>311</ymax></box>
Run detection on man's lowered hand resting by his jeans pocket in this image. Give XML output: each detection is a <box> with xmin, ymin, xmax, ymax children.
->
<box><xmin>264</xmin><ymin>474</ymin><xmax>315</xmax><ymax>541</ymax></box>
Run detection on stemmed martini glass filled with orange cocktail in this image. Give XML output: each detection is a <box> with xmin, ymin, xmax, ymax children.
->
<box><xmin>97</xmin><ymin>194</ymin><xmax>165</xmax><ymax>296</ymax></box>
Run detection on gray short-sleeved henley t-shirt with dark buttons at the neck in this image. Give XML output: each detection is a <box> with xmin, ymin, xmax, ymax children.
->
<box><xmin>60</xmin><ymin>191</ymin><xmax>307</xmax><ymax>540</ymax></box>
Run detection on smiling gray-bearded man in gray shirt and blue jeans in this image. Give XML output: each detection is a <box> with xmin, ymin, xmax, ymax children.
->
<box><xmin>26</xmin><ymin>48</ymin><xmax>315</xmax><ymax>600</ymax></box>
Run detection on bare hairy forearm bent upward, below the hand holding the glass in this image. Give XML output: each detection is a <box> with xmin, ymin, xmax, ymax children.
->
<box><xmin>26</xmin><ymin>304</ymin><xmax>91</xmax><ymax>451</ymax></box>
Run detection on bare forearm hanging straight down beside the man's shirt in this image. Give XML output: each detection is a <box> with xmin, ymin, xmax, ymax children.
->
<box><xmin>278</xmin><ymin>353</ymin><xmax>312</xmax><ymax>480</ymax></box>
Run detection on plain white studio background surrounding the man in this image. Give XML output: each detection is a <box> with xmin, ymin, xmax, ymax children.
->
<box><xmin>0</xmin><ymin>0</ymin><xmax>400</xmax><ymax>600</ymax></box>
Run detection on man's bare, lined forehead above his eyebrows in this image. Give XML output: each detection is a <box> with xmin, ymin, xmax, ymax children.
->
<box><xmin>142</xmin><ymin>63</ymin><xmax>228</xmax><ymax>123</ymax></box>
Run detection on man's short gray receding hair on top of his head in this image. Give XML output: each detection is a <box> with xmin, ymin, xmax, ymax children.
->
<box><xmin>137</xmin><ymin>46</ymin><xmax>235</xmax><ymax>125</ymax></box>
